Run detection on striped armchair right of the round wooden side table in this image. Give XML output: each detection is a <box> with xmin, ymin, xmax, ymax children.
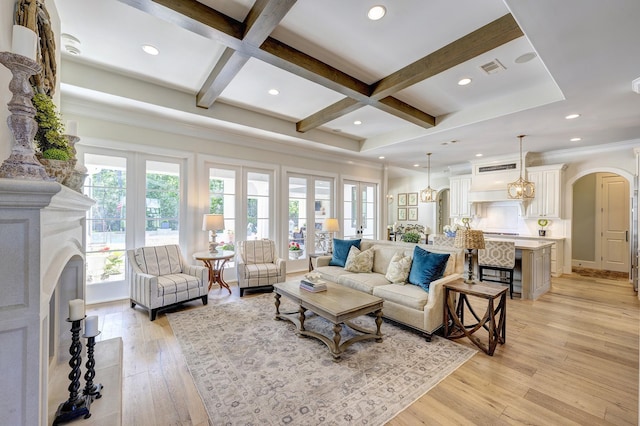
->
<box><xmin>236</xmin><ymin>239</ymin><xmax>287</xmax><ymax>297</ymax></box>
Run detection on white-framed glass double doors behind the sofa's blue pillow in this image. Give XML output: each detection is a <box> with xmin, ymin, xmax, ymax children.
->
<box><xmin>342</xmin><ymin>180</ymin><xmax>378</xmax><ymax>240</ymax></box>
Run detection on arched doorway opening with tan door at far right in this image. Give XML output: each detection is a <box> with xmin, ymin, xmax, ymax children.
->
<box><xmin>571</xmin><ymin>171</ymin><xmax>631</xmax><ymax>276</ymax></box>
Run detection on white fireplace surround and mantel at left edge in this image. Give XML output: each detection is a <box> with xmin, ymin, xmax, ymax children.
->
<box><xmin>0</xmin><ymin>179</ymin><xmax>94</xmax><ymax>425</ymax></box>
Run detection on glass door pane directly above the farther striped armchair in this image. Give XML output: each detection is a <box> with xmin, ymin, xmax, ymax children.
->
<box><xmin>247</xmin><ymin>172</ymin><xmax>271</xmax><ymax>239</ymax></box>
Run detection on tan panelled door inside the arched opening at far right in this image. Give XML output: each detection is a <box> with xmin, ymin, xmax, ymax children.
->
<box><xmin>600</xmin><ymin>173</ymin><xmax>629</xmax><ymax>272</ymax></box>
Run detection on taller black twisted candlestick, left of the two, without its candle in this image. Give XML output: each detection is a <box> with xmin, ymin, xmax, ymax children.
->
<box><xmin>53</xmin><ymin>317</ymin><xmax>91</xmax><ymax>426</ymax></box>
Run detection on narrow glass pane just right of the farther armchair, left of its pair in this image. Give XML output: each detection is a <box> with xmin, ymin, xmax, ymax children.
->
<box><xmin>289</xmin><ymin>177</ymin><xmax>307</xmax><ymax>259</ymax></box>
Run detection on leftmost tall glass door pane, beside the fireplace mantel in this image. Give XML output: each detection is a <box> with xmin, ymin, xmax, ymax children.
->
<box><xmin>84</xmin><ymin>154</ymin><xmax>127</xmax><ymax>284</ymax></box>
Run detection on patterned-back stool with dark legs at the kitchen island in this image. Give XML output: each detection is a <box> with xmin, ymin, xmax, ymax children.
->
<box><xmin>478</xmin><ymin>240</ymin><xmax>516</xmax><ymax>299</ymax></box>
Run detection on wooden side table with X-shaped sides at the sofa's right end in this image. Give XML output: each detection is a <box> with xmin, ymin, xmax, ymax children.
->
<box><xmin>444</xmin><ymin>280</ymin><xmax>509</xmax><ymax>355</ymax></box>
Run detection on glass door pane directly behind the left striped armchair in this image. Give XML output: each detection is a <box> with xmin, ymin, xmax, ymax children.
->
<box><xmin>145</xmin><ymin>161</ymin><xmax>180</xmax><ymax>246</ymax></box>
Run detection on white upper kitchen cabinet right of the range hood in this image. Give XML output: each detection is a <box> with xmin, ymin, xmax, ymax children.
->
<box><xmin>526</xmin><ymin>164</ymin><xmax>566</xmax><ymax>219</ymax></box>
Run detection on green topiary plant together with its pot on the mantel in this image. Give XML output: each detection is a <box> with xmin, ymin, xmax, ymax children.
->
<box><xmin>32</xmin><ymin>93</ymin><xmax>75</xmax><ymax>183</ymax></box>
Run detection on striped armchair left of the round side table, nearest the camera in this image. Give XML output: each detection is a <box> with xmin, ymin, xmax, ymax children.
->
<box><xmin>127</xmin><ymin>244</ymin><xmax>209</xmax><ymax>321</ymax></box>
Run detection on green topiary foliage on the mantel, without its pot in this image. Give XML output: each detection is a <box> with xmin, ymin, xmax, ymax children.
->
<box><xmin>32</xmin><ymin>93</ymin><xmax>73</xmax><ymax>160</ymax></box>
